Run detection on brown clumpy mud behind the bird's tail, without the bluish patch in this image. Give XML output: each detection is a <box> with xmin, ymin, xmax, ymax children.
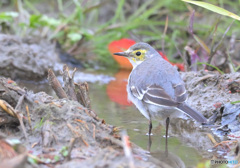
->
<box><xmin>181</xmin><ymin>71</ymin><xmax>240</xmax><ymax>118</ymax></box>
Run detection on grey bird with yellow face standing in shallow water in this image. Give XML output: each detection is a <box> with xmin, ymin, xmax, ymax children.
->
<box><xmin>114</xmin><ymin>42</ymin><xmax>207</xmax><ymax>143</ymax></box>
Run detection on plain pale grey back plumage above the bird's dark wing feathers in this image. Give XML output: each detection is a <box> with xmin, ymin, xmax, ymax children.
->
<box><xmin>129</xmin><ymin>54</ymin><xmax>186</xmax><ymax>101</ymax></box>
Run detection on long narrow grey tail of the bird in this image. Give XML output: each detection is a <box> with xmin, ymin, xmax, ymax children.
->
<box><xmin>178</xmin><ymin>103</ymin><xmax>207</xmax><ymax>123</ymax></box>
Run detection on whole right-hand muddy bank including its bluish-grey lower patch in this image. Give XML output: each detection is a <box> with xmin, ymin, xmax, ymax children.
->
<box><xmin>182</xmin><ymin>71</ymin><xmax>240</xmax><ymax>137</ymax></box>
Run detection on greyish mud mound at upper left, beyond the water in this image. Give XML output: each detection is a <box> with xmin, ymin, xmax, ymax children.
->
<box><xmin>0</xmin><ymin>34</ymin><xmax>60</xmax><ymax>80</ymax></box>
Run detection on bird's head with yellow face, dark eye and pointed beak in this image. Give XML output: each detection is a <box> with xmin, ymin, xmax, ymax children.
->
<box><xmin>114</xmin><ymin>42</ymin><xmax>159</xmax><ymax>67</ymax></box>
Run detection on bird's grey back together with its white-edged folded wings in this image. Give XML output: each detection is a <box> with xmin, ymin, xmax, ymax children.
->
<box><xmin>129</xmin><ymin>57</ymin><xmax>187</xmax><ymax>106</ymax></box>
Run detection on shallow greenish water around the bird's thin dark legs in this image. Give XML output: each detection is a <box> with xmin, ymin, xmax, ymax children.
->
<box><xmin>90</xmin><ymin>81</ymin><xmax>210</xmax><ymax>167</ymax></box>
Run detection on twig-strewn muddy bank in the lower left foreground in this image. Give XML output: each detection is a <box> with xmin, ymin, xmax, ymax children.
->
<box><xmin>0</xmin><ymin>75</ymin><xmax>164</xmax><ymax>167</ymax></box>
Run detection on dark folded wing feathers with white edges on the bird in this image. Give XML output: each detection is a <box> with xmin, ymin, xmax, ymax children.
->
<box><xmin>130</xmin><ymin>84</ymin><xmax>187</xmax><ymax>106</ymax></box>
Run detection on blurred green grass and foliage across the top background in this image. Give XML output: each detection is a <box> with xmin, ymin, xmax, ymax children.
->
<box><xmin>0</xmin><ymin>0</ymin><xmax>240</xmax><ymax>68</ymax></box>
